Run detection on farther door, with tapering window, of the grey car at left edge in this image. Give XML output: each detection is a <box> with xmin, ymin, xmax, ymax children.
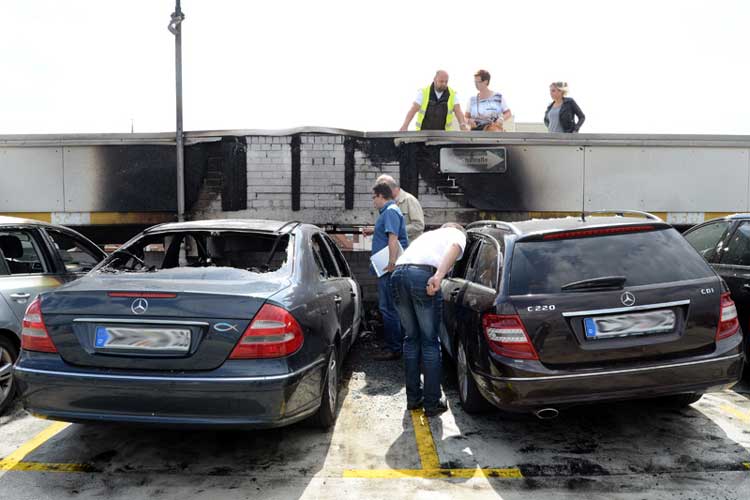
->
<box><xmin>43</xmin><ymin>227</ymin><xmax>107</xmax><ymax>281</ymax></box>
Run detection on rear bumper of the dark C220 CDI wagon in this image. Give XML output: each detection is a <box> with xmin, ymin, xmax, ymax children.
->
<box><xmin>473</xmin><ymin>350</ymin><xmax>744</xmax><ymax>412</ymax></box>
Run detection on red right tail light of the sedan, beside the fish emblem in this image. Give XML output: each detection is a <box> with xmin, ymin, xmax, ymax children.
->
<box><xmin>229</xmin><ymin>304</ymin><xmax>304</xmax><ymax>359</ymax></box>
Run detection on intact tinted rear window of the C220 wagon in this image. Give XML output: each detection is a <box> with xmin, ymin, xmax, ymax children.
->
<box><xmin>510</xmin><ymin>229</ymin><xmax>713</xmax><ymax>295</ymax></box>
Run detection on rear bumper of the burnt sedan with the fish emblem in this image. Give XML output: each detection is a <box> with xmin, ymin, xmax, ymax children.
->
<box><xmin>14</xmin><ymin>355</ymin><xmax>325</xmax><ymax>428</ymax></box>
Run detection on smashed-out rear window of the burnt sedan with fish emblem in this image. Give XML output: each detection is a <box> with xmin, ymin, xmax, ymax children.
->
<box><xmin>98</xmin><ymin>231</ymin><xmax>292</xmax><ymax>279</ymax></box>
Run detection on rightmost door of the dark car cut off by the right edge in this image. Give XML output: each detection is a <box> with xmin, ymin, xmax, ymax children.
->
<box><xmin>713</xmin><ymin>221</ymin><xmax>750</xmax><ymax>335</ymax></box>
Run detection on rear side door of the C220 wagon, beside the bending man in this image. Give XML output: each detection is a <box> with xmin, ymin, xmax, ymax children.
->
<box><xmin>460</xmin><ymin>235</ymin><xmax>502</xmax><ymax>370</ymax></box>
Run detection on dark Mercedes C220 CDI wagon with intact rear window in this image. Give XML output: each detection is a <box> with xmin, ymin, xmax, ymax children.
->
<box><xmin>442</xmin><ymin>213</ymin><xmax>743</xmax><ymax>418</ymax></box>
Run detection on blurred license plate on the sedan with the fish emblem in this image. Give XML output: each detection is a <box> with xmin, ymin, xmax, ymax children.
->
<box><xmin>94</xmin><ymin>326</ymin><xmax>190</xmax><ymax>353</ymax></box>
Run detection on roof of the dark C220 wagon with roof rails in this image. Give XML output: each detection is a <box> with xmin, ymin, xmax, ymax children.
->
<box><xmin>471</xmin><ymin>215</ymin><xmax>669</xmax><ymax>236</ymax></box>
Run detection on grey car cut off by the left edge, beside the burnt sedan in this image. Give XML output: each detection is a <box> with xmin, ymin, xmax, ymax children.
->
<box><xmin>0</xmin><ymin>217</ymin><xmax>107</xmax><ymax>413</ymax></box>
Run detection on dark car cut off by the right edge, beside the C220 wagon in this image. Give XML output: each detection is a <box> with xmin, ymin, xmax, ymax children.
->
<box><xmin>683</xmin><ymin>214</ymin><xmax>750</xmax><ymax>359</ymax></box>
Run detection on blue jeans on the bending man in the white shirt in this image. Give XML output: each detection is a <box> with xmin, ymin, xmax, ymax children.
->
<box><xmin>391</xmin><ymin>266</ymin><xmax>443</xmax><ymax>409</ymax></box>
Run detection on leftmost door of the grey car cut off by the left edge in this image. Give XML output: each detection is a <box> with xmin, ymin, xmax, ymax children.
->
<box><xmin>0</xmin><ymin>226</ymin><xmax>64</xmax><ymax>324</ymax></box>
